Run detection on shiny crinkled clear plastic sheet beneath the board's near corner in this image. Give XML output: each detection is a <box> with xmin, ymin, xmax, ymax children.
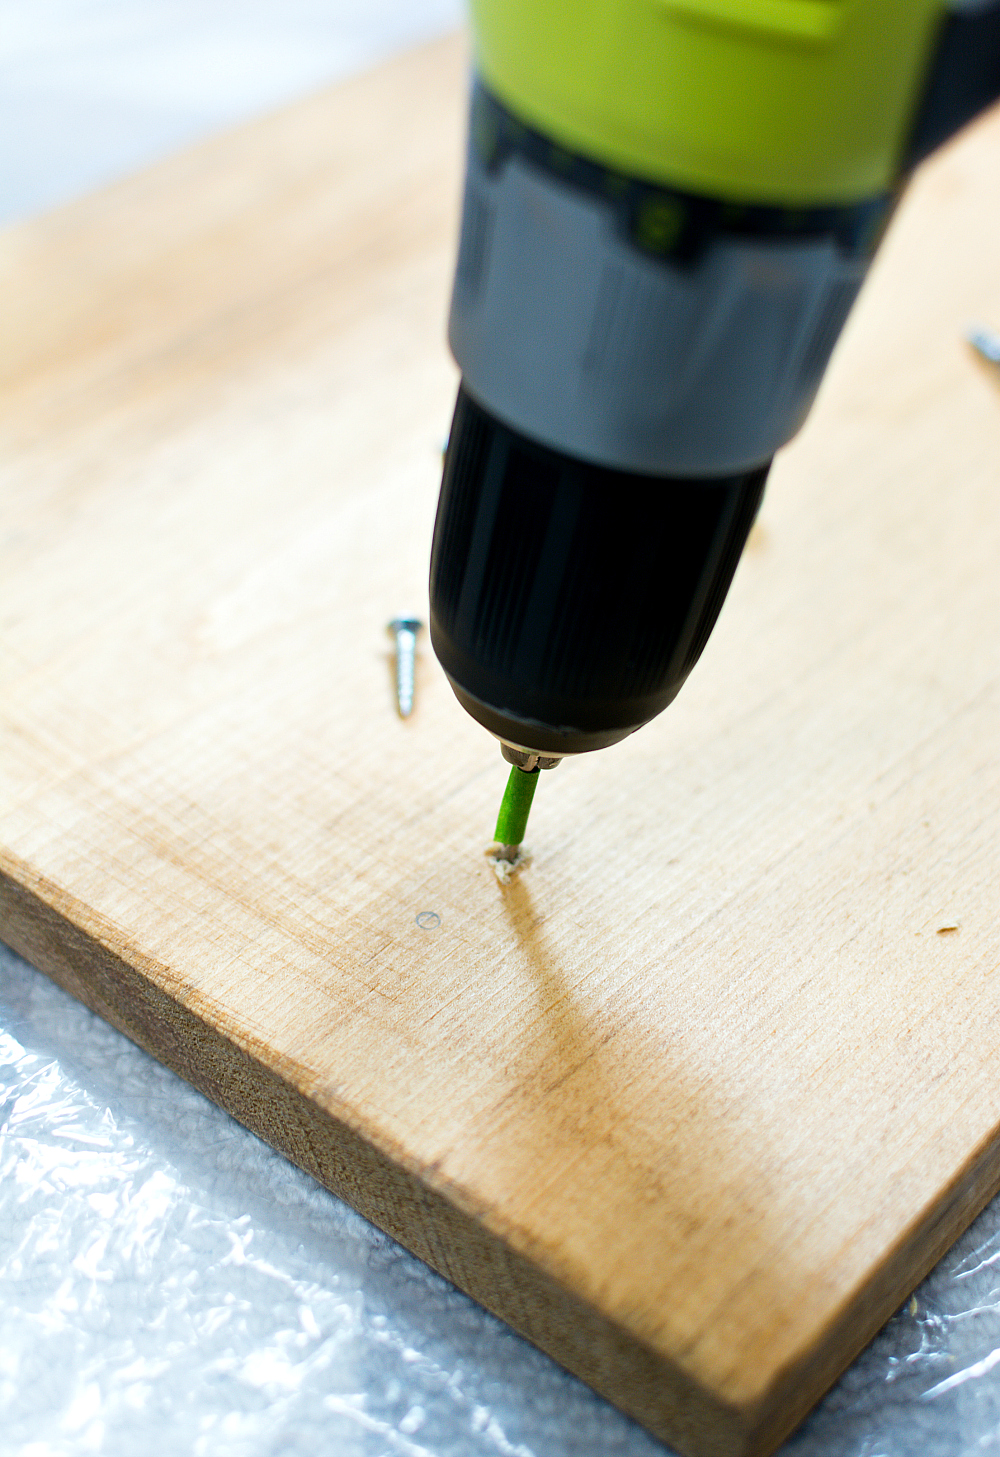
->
<box><xmin>0</xmin><ymin>949</ymin><xmax>1000</xmax><ymax>1457</ymax></box>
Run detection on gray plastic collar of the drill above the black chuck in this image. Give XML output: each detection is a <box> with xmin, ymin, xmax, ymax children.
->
<box><xmin>449</xmin><ymin>124</ymin><xmax>867</xmax><ymax>476</ymax></box>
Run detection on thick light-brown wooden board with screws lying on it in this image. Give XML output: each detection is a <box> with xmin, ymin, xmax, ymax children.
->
<box><xmin>0</xmin><ymin>41</ymin><xmax>1000</xmax><ymax>1457</ymax></box>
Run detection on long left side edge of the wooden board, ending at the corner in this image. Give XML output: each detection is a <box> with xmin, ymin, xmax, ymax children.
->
<box><xmin>0</xmin><ymin>855</ymin><xmax>751</xmax><ymax>1457</ymax></box>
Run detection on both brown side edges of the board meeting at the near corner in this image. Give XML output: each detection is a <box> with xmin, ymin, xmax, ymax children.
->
<box><xmin>7</xmin><ymin>855</ymin><xmax>1000</xmax><ymax>1457</ymax></box>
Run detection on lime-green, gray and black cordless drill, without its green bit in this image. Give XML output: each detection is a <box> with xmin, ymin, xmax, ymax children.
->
<box><xmin>430</xmin><ymin>0</ymin><xmax>1000</xmax><ymax>771</ymax></box>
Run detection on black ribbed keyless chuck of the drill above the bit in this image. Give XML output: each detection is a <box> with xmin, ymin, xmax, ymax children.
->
<box><xmin>430</xmin><ymin>390</ymin><xmax>768</xmax><ymax>753</ymax></box>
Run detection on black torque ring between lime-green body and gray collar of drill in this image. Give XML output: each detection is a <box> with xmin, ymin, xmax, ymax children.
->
<box><xmin>469</xmin><ymin>80</ymin><xmax>898</xmax><ymax>265</ymax></box>
